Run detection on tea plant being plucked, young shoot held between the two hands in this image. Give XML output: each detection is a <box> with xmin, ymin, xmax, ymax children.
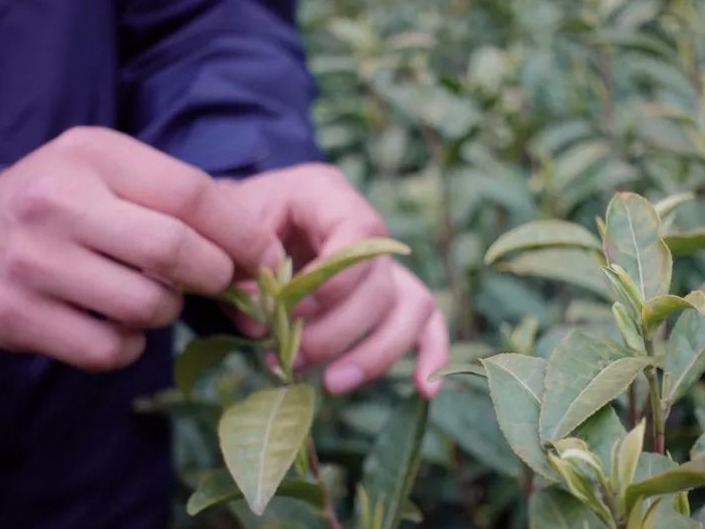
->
<box><xmin>175</xmin><ymin>239</ymin><xmax>427</xmax><ymax>529</ymax></box>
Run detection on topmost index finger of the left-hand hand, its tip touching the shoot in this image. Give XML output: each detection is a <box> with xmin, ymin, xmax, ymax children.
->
<box><xmin>46</xmin><ymin>128</ymin><xmax>282</xmax><ymax>272</ymax></box>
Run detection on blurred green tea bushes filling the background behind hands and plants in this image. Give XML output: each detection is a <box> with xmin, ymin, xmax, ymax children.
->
<box><xmin>166</xmin><ymin>0</ymin><xmax>705</xmax><ymax>529</ymax></box>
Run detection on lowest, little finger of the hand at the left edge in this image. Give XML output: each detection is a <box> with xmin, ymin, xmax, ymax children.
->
<box><xmin>0</xmin><ymin>286</ymin><xmax>145</xmax><ymax>371</ymax></box>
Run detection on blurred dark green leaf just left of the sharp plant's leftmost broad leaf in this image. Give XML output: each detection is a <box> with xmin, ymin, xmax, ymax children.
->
<box><xmin>431</xmin><ymin>387</ymin><xmax>522</xmax><ymax>478</ymax></box>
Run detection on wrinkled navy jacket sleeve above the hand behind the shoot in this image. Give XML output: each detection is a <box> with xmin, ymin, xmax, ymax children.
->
<box><xmin>120</xmin><ymin>0</ymin><xmax>321</xmax><ymax>176</ymax></box>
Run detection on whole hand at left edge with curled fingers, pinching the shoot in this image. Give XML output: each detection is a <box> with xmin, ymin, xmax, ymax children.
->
<box><xmin>0</xmin><ymin>128</ymin><xmax>282</xmax><ymax>370</ymax></box>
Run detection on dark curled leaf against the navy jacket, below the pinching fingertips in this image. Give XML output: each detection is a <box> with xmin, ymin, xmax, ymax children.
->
<box><xmin>174</xmin><ymin>335</ymin><xmax>262</xmax><ymax>397</ymax></box>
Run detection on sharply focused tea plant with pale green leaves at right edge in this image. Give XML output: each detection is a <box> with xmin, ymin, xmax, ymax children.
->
<box><xmin>442</xmin><ymin>193</ymin><xmax>705</xmax><ymax>529</ymax></box>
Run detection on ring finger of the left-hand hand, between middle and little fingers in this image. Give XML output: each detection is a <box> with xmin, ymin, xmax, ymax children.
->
<box><xmin>12</xmin><ymin>241</ymin><xmax>182</xmax><ymax>328</ymax></box>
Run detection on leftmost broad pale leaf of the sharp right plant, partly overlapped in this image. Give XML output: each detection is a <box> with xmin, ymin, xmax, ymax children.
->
<box><xmin>482</xmin><ymin>353</ymin><xmax>555</xmax><ymax>479</ymax></box>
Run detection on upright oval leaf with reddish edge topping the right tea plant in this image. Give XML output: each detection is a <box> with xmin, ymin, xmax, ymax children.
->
<box><xmin>604</xmin><ymin>193</ymin><xmax>673</xmax><ymax>300</ymax></box>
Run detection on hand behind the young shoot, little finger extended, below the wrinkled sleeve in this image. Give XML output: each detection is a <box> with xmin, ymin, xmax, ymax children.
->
<box><xmin>222</xmin><ymin>164</ymin><xmax>448</xmax><ymax>397</ymax></box>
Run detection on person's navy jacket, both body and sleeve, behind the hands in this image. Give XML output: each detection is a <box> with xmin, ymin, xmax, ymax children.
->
<box><xmin>0</xmin><ymin>0</ymin><xmax>319</xmax><ymax>529</ymax></box>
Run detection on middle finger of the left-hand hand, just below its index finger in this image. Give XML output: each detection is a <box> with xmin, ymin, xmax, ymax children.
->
<box><xmin>77</xmin><ymin>195</ymin><xmax>233</xmax><ymax>295</ymax></box>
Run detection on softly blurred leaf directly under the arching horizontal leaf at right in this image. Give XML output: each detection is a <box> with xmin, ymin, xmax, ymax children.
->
<box><xmin>498</xmin><ymin>248</ymin><xmax>611</xmax><ymax>299</ymax></box>
